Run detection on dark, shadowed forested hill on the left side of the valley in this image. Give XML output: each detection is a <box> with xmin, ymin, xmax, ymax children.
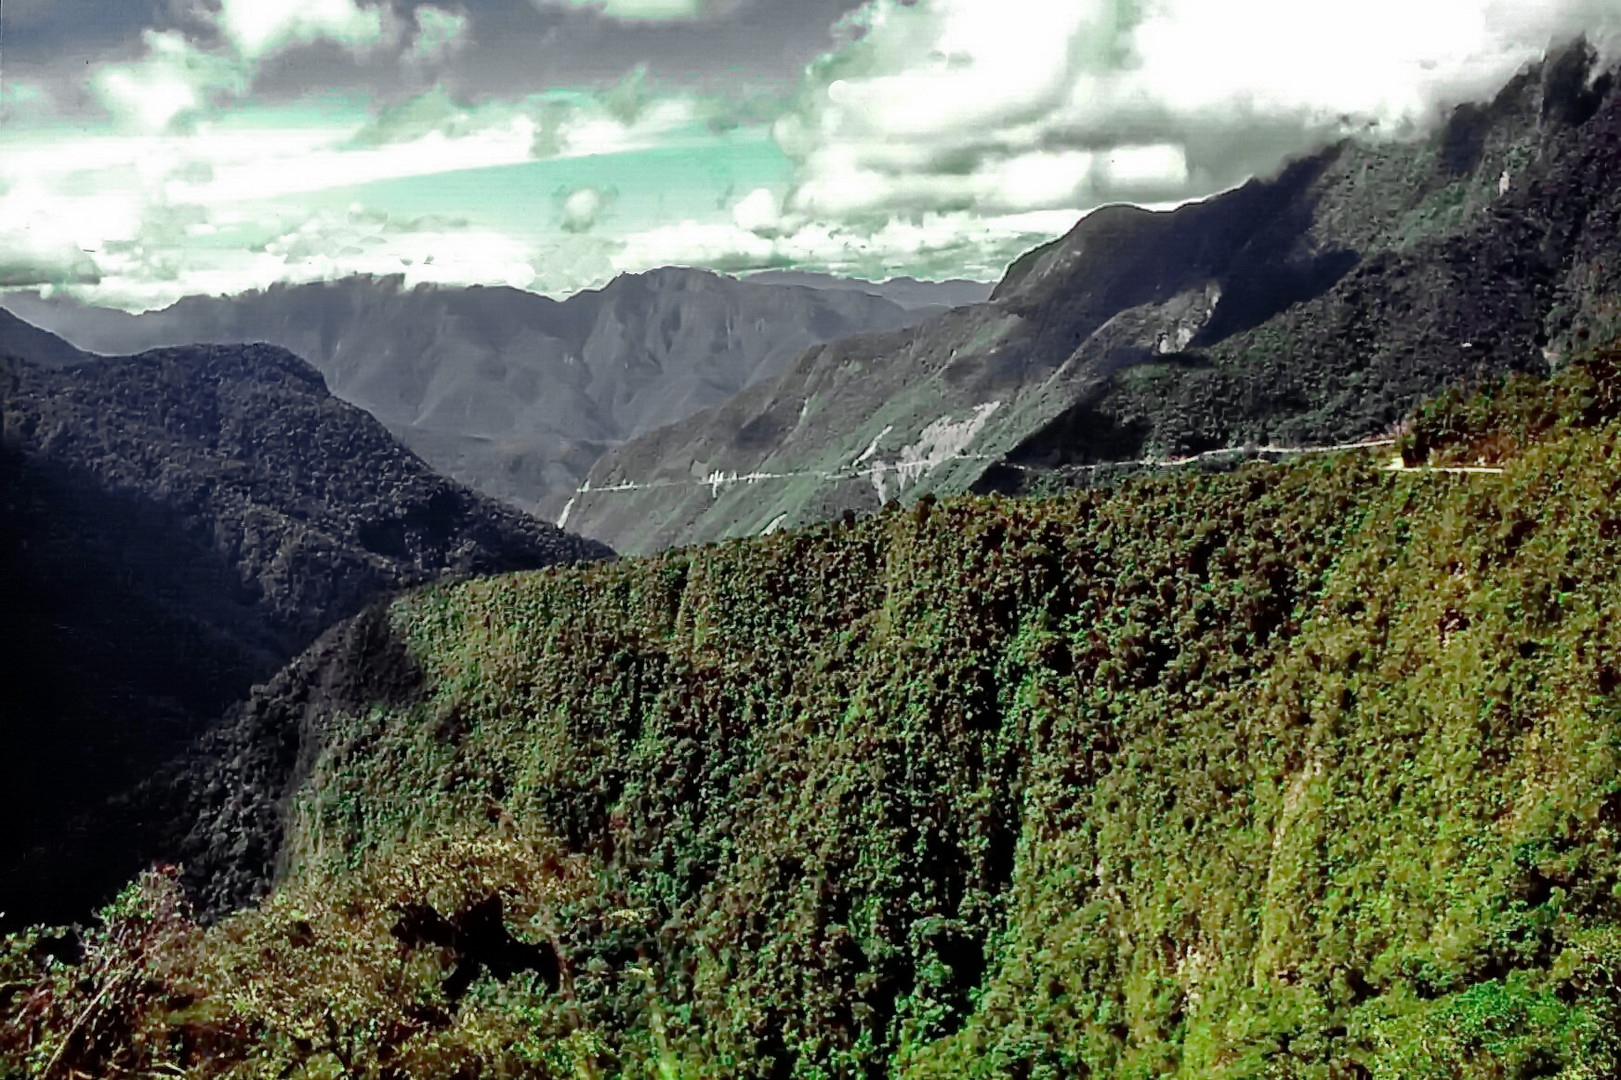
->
<box><xmin>0</xmin><ymin>345</ymin><xmax>611</xmax><ymax>918</ymax></box>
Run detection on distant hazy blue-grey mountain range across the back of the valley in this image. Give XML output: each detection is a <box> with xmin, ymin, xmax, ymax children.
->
<box><xmin>6</xmin><ymin>268</ymin><xmax>946</xmax><ymax>517</ymax></box>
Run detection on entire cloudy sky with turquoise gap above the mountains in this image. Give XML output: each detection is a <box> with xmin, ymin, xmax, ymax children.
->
<box><xmin>0</xmin><ymin>0</ymin><xmax>1621</xmax><ymax>310</ymax></box>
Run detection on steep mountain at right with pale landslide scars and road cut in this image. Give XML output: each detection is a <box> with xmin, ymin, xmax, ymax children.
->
<box><xmin>567</xmin><ymin>44</ymin><xmax>1621</xmax><ymax>551</ymax></box>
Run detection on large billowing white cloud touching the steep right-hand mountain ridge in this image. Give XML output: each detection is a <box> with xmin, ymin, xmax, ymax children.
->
<box><xmin>773</xmin><ymin>0</ymin><xmax>1621</xmax><ymax>222</ymax></box>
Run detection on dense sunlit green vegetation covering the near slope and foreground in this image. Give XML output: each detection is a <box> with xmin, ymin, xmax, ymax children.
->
<box><xmin>9</xmin><ymin>350</ymin><xmax>1621</xmax><ymax>1080</ymax></box>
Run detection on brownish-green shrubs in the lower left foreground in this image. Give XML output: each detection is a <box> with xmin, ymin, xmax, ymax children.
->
<box><xmin>0</xmin><ymin>827</ymin><xmax>609</xmax><ymax>1080</ymax></box>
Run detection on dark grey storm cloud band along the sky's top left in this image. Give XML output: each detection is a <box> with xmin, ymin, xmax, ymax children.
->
<box><xmin>3</xmin><ymin>0</ymin><xmax>859</xmax><ymax>112</ymax></box>
